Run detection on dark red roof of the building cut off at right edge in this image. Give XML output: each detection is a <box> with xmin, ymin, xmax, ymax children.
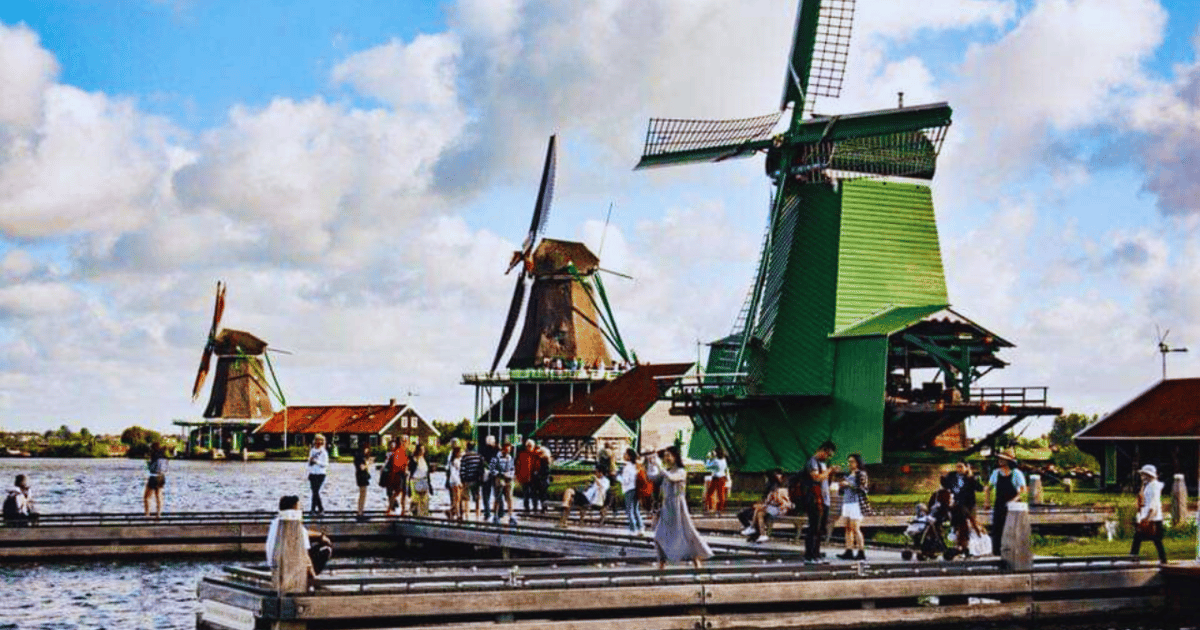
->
<box><xmin>1076</xmin><ymin>378</ymin><xmax>1200</xmax><ymax>439</ymax></box>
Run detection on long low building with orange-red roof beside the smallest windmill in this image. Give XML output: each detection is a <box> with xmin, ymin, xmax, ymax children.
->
<box><xmin>250</xmin><ymin>398</ymin><xmax>438</xmax><ymax>455</ymax></box>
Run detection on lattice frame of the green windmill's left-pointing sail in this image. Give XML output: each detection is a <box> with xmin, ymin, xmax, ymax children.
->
<box><xmin>642</xmin><ymin>112</ymin><xmax>784</xmax><ymax>161</ymax></box>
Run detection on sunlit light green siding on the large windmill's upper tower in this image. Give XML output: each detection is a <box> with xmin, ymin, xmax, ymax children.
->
<box><xmin>834</xmin><ymin>179</ymin><xmax>949</xmax><ymax>330</ymax></box>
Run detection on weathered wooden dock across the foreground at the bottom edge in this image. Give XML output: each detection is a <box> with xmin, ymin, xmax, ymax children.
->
<box><xmin>198</xmin><ymin>557</ymin><xmax>1194</xmax><ymax>630</ymax></box>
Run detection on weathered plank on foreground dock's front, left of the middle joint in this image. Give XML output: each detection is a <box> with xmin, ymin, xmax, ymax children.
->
<box><xmin>290</xmin><ymin>584</ymin><xmax>703</xmax><ymax>619</ymax></box>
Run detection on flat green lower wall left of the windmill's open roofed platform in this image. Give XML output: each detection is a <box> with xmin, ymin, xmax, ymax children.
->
<box><xmin>830</xmin><ymin>336</ymin><xmax>888</xmax><ymax>463</ymax></box>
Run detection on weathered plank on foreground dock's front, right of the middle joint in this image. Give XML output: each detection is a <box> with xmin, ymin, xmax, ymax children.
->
<box><xmin>704</xmin><ymin>574</ymin><xmax>1031</xmax><ymax>605</ymax></box>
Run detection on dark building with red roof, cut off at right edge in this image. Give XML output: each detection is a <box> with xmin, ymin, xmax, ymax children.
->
<box><xmin>1075</xmin><ymin>378</ymin><xmax>1200</xmax><ymax>488</ymax></box>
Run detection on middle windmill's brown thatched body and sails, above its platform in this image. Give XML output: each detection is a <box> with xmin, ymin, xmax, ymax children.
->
<box><xmin>491</xmin><ymin>136</ymin><xmax>629</xmax><ymax>373</ymax></box>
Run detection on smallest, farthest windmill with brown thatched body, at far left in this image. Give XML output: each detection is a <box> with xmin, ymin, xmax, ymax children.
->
<box><xmin>192</xmin><ymin>282</ymin><xmax>274</xmax><ymax>418</ymax></box>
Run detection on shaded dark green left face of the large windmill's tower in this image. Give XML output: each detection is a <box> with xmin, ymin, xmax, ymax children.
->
<box><xmin>751</xmin><ymin>184</ymin><xmax>840</xmax><ymax>396</ymax></box>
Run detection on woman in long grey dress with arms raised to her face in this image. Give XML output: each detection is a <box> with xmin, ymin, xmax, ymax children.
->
<box><xmin>647</xmin><ymin>446</ymin><xmax>713</xmax><ymax>569</ymax></box>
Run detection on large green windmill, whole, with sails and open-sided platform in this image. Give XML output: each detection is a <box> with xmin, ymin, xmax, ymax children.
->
<box><xmin>637</xmin><ymin>0</ymin><xmax>1061</xmax><ymax>472</ymax></box>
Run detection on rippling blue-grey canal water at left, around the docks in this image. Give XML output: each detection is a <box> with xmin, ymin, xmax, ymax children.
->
<box><xmin>0</xmin><ymin>458</ymin><xmax>446</xmax><ymax>630</ymax></box>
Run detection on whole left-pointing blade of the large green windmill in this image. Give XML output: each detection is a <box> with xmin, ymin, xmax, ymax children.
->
<box><xmin>634</xmin><ymin>112</ymin><xmax>782</xmax><ymax>170</ymax></box>
